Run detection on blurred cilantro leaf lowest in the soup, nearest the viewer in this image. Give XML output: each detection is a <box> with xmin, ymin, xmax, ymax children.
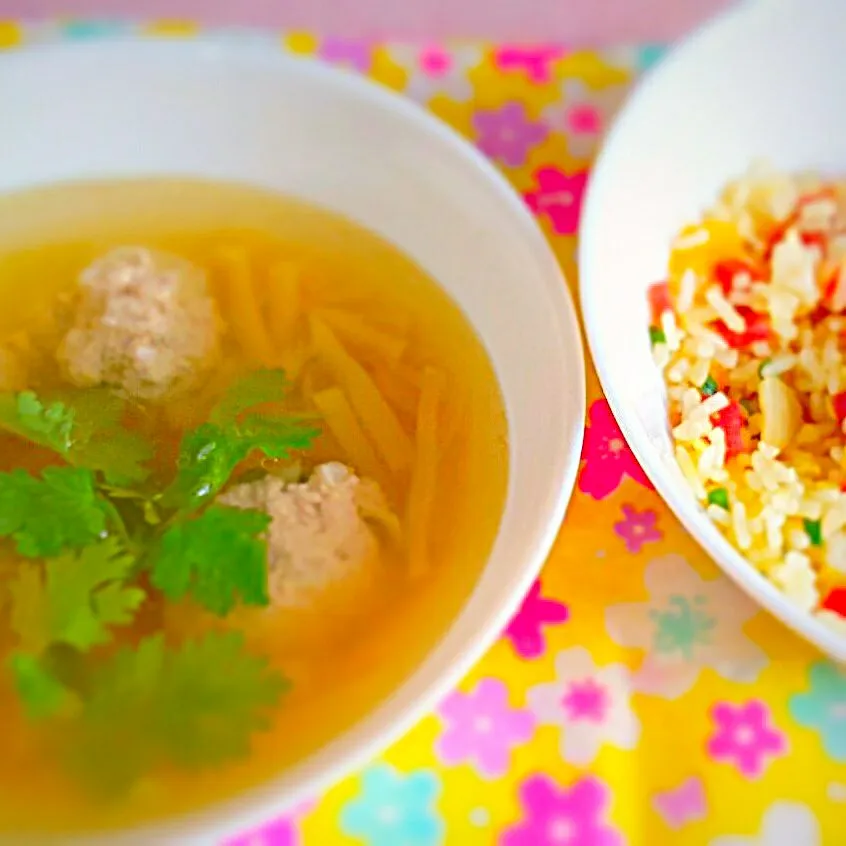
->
<box><xmin>65</xmin><ymin>632</ymin><xmax>286</xmax><ymax>793</ymax></box>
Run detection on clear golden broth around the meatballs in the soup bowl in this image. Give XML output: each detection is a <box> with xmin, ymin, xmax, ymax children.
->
<box><xmin>0</xmin><ymin>179</ymin><xmax>508</xmax><ymax>833</ymax></box>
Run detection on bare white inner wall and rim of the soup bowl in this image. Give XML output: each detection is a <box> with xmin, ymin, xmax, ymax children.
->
<box><xmin>0</xmin><ymin>40</ymin><xmax>585</xmax><ymax>843</ymax></box>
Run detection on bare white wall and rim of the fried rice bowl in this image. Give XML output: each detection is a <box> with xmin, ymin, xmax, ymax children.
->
<box><xmin>579</xmin><ymin>0</ymin><xmax>846</xmax><ymax>659</ymax></box>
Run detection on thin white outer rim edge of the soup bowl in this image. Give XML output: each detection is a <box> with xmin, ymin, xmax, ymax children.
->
<box><xmin>0</xmin><ymin>30</ymin><xmax>587</xmax><ymax>846</ymax></box>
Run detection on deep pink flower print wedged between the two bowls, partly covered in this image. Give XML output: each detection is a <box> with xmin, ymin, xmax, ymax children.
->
<box><xmin>579</xmin><ymin>399</ymin><xmax>652</xmax><ymax>499</ymax></box>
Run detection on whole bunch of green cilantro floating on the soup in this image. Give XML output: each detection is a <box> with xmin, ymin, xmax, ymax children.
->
<box><xmin>0</xmin><ymin>371</ymin><xmax>319</xmax><ymax>792</ymax></box>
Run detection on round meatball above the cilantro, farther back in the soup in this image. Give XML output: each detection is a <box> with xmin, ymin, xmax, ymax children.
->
<box><xmin>58</xmin><ymin>247</ymin><xmax>220</xmax><ymax>400</ymax></box>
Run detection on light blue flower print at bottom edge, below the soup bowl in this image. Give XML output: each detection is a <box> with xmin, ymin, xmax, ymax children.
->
<box><xmin>341</xmin><ymin>764</ymin><xmax>443</xmax><ymax>846</ymax></box>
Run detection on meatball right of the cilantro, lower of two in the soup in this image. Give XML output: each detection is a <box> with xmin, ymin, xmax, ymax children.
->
<box><xmin>219</xmin><ymin>462</ymin><xmax>387</xmax><ymax>608</ymax></box>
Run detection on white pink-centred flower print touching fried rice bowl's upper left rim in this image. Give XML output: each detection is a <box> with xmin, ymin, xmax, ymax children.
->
<box><xmin>542</xmin><ymin>79</ymin><xmax>629</xmax><ymax>159</ymax></box>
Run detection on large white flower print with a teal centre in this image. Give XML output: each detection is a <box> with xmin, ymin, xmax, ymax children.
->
<box><xmin>605</xmin><ymin>555</ymin><xmax>768</xmax><ymax>699</ymax></box>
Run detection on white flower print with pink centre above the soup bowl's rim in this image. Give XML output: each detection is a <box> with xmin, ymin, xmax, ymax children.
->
<box><xmin>388</xmin><ymin>44</ymin><xmax>483</xmax><ymax>103</ymax></box>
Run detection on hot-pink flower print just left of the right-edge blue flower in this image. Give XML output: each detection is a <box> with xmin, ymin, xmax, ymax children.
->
<box><xmin>708</xmin><ymin>699</ymin><xmax>787</xmax><ymax>778</ymax></box>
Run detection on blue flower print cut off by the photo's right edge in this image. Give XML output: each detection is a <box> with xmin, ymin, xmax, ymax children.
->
<box><xmin>790</xmin><ymin>661</ymin><xmax>846</xmax><ymax>762</ymax></box>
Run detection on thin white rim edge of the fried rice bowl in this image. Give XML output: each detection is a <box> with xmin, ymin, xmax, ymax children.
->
<box><xmin>579</xmin><ymin>0</ymin><xmax>846</xmax><ymax>662</ymax></box>
